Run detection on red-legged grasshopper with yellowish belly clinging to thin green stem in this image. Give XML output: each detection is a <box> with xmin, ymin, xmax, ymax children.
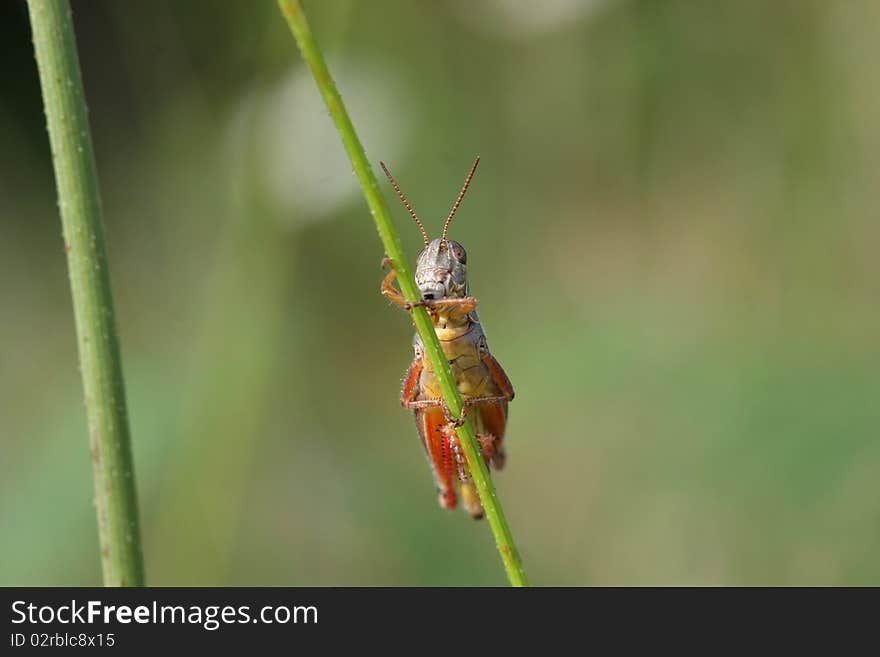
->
<box><xmin>380</xmin><ymin>158</ymin><xmax>513</xmax><ymax>518</ymax></box>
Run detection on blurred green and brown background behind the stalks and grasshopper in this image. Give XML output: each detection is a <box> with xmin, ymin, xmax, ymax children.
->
<box><xmin>0</xmin><ymin>0</ymin><xmax>880</xmax><ymax>585</ymax></box>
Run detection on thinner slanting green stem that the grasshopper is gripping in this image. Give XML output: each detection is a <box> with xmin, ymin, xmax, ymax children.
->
<box><xmin>278</xmin><ymin>0</ymin><xmax>528</xmax><ymax>586</ymax></box>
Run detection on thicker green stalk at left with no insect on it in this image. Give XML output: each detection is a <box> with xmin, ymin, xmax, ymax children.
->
<box><xmin>28</xmin><ymin>0</ymin><xmax>144</xmax><ymax>586</ymax></box>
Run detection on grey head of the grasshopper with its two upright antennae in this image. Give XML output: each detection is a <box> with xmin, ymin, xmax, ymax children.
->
<box><xmin>379</xmin><ymin>157</ymin><xmax>480</xmax><ymax>301</ymax></box>
